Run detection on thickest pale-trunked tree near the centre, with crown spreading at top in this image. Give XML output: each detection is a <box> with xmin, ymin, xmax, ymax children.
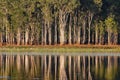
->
<box><xmin>55</xmin><ymin>0</ymin><xmax>78</xmax><ymax>45</ymax></box>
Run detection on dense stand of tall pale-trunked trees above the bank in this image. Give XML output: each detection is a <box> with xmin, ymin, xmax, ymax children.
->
<box><xmin>0</xmin><ymin>0</ymin><xmax>120</xmax><ymax>45</ymax></box>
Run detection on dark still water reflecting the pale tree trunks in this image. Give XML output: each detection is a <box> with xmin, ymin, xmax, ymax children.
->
<box><xmin>0</xmin><ymin>55</ymin><xmax>120</xmax><ymax>80</ymax></box>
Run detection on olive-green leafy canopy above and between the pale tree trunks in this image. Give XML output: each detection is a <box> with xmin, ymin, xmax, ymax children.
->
<box><xmin>0</xmin><ymin>0</ymin><xmax>120</xmax><ymax>44</ymax></box>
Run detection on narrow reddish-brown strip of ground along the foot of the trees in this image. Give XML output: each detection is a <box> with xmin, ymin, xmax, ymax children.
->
<box><xmin>0</xmin><ymin>44</ymin><xmax>120</xmax><ymax>48</ymax></box>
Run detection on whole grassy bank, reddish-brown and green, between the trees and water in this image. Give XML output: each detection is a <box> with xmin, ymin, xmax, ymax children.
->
<box><xmin>0</xmin><ymin>45</ymin><xmax>120</xmax><ymax>53</ymax></box>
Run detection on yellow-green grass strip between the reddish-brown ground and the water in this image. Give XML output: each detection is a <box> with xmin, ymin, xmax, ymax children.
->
<box><xmin>0</xmin><ymin>47</ymin><xmax>120</xmax><ymax>53</ymax></box>
